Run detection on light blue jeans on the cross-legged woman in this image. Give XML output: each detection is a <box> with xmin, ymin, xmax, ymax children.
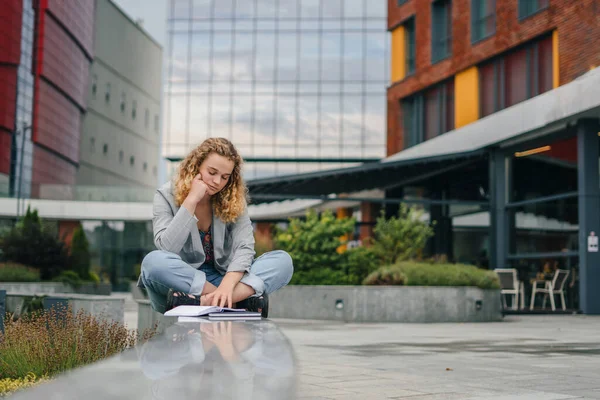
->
<box><xmin>141</xmin><ymin>250</ymin><xmax>294</xmax><ymax>313</ymax></box>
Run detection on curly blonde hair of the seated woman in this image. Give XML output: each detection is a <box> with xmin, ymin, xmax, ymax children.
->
<box><xmin>173</xmin><ymin>138</ymin><xmax>248</xmax><ymax>222</ymax></box>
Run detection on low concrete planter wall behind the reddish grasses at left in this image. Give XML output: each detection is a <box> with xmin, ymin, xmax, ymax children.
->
<box><xmin>6</xmin><ymin>293</ymin><xmax>125</xmax><ymax>323</ymax></box>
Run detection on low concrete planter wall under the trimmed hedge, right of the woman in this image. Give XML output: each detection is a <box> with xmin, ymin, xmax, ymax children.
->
<box><xmin>269</xmin><ymin>286</ymin><xmax>502</xmax><ymax>323</ymax></box>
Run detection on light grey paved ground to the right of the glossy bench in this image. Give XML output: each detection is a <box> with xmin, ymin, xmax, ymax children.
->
<box><xmin>274</xmin><ymin>315</ymin><xmax>600</xmax><ymax>400</ymax></box>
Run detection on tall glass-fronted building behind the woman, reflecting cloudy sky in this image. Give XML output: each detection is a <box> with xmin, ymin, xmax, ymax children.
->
<box><xmin>163</xmin><ymin>0</ymin><xmax>389</xmax><ymax>179</ymax></box>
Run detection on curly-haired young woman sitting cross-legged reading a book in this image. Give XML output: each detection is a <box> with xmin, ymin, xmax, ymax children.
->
<box><xmin>138</xmin><ymin>138</ymin><xmax>293</xmax><ymax>318</ymax></box>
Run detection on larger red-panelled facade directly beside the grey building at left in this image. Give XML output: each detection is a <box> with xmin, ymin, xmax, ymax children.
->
<box><xmin>32</xmin><ymin>0</ymin><xmax>94</xmax><ymax>190</ymax></box>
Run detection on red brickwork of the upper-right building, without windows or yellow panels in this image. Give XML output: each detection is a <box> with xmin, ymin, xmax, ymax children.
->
<box><xmin>387</xmin><ymin>0</ymin><xmax>600</xmax><ymax>154</ymax></box>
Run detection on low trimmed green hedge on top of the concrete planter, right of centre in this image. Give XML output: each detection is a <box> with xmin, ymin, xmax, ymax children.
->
<box><xmin>363</xmin><ymin>261</ymin><xmax>500</xmax><ymax>289</ymax></box>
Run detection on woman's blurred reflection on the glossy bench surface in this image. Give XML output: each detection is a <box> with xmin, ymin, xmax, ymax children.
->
<box><xmin>140</xmin><ymin>320</ymin><xmax>295</xmax><ymax>399</ymax></box>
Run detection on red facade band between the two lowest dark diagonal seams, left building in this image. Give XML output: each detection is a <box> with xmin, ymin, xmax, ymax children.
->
<box><xmin>36</xmin><ymin>80</ymin><xmax>81</xmax><ymax>163</ymax></box>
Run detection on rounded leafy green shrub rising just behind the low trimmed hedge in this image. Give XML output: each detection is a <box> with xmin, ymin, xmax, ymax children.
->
<box><xmin>372</xmin><ymin>204</ymin><xmax>433</xmax><ymax>265</ymax></box>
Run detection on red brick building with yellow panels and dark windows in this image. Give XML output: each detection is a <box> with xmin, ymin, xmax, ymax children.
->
<box><xmin>387</xmin><ymin>0</ymin><xmax>600</xmax><ymax>155</ymax></box>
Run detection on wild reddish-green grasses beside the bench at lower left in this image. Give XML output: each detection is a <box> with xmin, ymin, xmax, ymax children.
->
<box><xmin>0</xmin><ymin>308</ymin><xmax>156</xmax><ymax>379</ymax></box>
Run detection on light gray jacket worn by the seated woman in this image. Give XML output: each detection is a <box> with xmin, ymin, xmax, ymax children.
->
<box><xmin>138</xmin><ymin>182</ymin><xmax>256</xmax><ymax>286</ymax></box>
